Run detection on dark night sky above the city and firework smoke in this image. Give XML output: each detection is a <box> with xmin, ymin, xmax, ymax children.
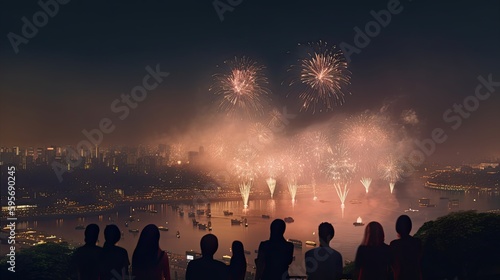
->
<box><xmin>0</xmin><ymin>0</ymin><xmax>500</xmax><ymax>161</ymax></box>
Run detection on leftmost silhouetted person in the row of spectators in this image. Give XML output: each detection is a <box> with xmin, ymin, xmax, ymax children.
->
<box><xmin>73</xmin><ymin>224</ymin><xmax>102</xmax><ymax>280</ymax></box>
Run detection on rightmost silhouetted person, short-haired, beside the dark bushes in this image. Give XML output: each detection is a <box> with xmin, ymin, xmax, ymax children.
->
<box><xmin>390</xmin><ymin>215</ymin><xmax>422</xmax><ymax>280</ymax></box>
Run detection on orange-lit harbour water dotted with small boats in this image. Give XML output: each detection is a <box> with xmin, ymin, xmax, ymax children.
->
<box><xmin>1</xmin><ymin>175</ymin><xmax>500</xmax><ymax>275</ymax></box>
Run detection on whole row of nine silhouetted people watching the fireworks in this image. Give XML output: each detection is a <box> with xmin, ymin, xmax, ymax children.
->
<box><xmin>73</xmin><ymin>215</ymin><xmax>422</xmax><ymax>280</ymax></box>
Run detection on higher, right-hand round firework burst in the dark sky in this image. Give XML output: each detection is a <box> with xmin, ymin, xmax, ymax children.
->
<box><xmin>289</xmin><ymin>41</ymin><xmax>350</xmax><ymax>113</ymax></box>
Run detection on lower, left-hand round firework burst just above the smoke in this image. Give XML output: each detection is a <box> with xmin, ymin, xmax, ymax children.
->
<box><xmin>210</xmin><ymin>57</ymin><xmax>270</xmax><ymax>116</ymax></box>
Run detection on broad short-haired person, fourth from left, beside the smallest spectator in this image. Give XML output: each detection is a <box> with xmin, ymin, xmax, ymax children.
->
<box><xmin>186</xmin><ymin>233</ymin><xmax>229</xmax><ymax>280</ymax></box>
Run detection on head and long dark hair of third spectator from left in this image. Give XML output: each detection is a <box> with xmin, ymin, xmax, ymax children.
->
<box><xmin>132</xmin><ymin>224</ymin><xmax>160</xmax><ymax>269</ymax></box>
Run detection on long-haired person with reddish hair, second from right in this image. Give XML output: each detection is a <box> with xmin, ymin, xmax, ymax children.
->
<box><xmin>354</xmin><ymin>222</ymin><xmax>392</xmax><ymax>280</ymax></box>
